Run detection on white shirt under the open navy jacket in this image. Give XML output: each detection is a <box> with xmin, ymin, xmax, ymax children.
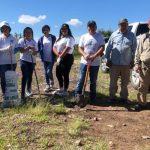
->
<box><xmin>43</xmin><ymin>36</ymin><xmax>52</xmax><ymax>62</ymax></box>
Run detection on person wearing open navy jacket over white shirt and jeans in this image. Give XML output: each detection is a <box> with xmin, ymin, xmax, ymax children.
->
<box><xmin>38</xmin><ymin>25</ymin><xmax>56</xmax><ymax>92</ymax></box>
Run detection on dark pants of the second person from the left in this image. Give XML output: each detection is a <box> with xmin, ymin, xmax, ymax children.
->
<box><xmin>20</xmin><ymin>60</ymin><xmax>35</xmax><ymax>97</ymax></box>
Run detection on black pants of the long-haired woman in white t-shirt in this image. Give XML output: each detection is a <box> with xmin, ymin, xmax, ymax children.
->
<box><xmin>56</xmin><ymin>54</ymin><xmax>74</xmax><ymax>90</ymax></box>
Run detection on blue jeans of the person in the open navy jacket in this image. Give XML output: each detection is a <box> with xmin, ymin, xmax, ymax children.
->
<box><xmin>43</xmin><ymin>61</ymin><xmax>54</xmax><ymax>85</ymax></box>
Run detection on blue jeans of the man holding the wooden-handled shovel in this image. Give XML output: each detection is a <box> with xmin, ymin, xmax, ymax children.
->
<box><xmin>75</xmin><ymin>63</ymin><xmax>99</xmax><ymax>101</ymax></box>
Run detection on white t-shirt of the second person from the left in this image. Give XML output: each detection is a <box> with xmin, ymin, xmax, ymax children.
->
<box><xmin>18</xmin><ymin>38</ymin><xmax>38</xmax><ymax>63</ymax></box>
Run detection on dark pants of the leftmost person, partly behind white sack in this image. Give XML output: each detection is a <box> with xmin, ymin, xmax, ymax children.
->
<box><xmin>0</xmin><ymin>64</ymin><xmax>17</xmax><ymax>95</ymax></box>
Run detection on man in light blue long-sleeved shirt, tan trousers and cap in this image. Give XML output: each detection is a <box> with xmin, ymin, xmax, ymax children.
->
<box><xmin>105</xmin><ymin>18</ymin><xmax>137</xmax><ymax>103</ymax></box>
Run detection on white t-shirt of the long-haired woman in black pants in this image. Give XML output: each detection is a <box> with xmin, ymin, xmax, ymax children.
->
<box><xmin>54</xmin><ymin>36</ymin><xmax>75</xmax><ymax>54</ymax></box>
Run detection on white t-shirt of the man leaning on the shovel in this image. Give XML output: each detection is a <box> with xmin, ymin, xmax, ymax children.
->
<box><xmin>79</xmin><ymin>33</ymin><xmax>105</xmax><ymax>66</ymax></box>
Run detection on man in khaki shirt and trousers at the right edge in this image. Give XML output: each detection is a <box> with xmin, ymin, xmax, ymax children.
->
<box><xmin>134</xmin><ymin>20</ymin><xmax>150</xmax><ymax>110</ymax></box>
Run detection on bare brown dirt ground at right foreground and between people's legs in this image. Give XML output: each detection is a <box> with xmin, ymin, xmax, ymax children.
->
<box><xmin>0</xmin><ymin>59</ymin><xmax>150</xmax><ymax>150</ymax></box>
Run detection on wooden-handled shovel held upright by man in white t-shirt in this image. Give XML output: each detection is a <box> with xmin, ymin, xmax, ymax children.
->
<box><xmin>76</xmin><ymin>64</ymin><xmax>90</xmax><ymax>108</ymax></box>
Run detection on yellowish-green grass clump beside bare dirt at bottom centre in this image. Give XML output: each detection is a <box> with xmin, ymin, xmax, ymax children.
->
<box><xmin>67</xmin><ymin>118</ymin><xmax>89</xmax><ymax>136</ymax></box>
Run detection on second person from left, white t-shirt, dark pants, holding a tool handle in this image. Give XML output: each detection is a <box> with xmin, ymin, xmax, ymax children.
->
<box><xmin>18</xmin><ymin>27</ymin><xmax>38</xmax><ymax>102</ymax></box>
